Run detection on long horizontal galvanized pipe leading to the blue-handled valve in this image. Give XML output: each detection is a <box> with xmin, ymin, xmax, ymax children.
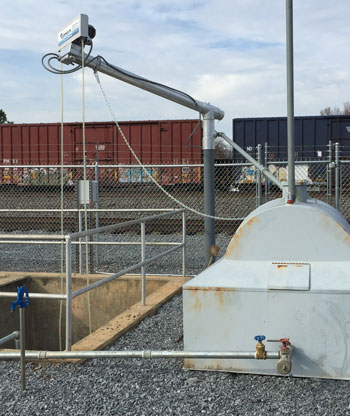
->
<box><xmin>0</xmin><ymin>350</ymin><xmax>280</xmax><ymax>360</ymax></box>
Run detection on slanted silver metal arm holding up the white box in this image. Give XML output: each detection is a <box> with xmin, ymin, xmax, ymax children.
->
<box><xmin>61</xmin><ymin>43</ymin><xmax>225</xmax><ymax>120</ymax></box>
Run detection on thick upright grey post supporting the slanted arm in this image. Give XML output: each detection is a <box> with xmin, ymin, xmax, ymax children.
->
<box><xmin>203</xmin><ymin>111</ymin><xmax>216</xmax><ymax>265</ymax></box>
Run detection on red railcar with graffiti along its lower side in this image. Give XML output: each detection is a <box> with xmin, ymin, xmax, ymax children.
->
<box><xmin>0</xmin><ymin>120</ymin><xmax>202</xmax><ymax>185</ymax></box>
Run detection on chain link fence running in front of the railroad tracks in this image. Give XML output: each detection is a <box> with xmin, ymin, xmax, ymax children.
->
<box><xmin>0</xmin><ymin>144</ymin><xmax>350</xmax><ymax>274</ymax></box>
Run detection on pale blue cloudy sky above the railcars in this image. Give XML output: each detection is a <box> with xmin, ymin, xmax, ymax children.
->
<box><xmin>0</xmin><ymin>0</ymin><xmax>350</xmax><ymax>136</ymax></box>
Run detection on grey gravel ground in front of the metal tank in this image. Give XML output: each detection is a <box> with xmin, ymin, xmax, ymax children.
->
<box><xmin>0</xmin><ymin>296</ymin><xmax>350</xmax><ymax>416</ymax></box>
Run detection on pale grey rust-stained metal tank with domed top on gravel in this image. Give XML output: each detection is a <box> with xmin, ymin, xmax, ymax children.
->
<box><xmin>183</xmin><ymin>185</ymin><xmax>350</xmax><ymax>379</ymax></box>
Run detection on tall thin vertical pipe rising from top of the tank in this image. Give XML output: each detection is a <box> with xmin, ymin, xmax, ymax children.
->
<box><xmin>286</xmin><ymin>0</ymin><xmax>295</xmax><ymax>202</ymax></box>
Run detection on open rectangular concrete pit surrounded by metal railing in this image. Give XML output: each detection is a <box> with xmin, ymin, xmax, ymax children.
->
<box><xmin>0</xmin><ymin>272</ymin><xmax>189</xmax><ymax>351</ymax></box>
